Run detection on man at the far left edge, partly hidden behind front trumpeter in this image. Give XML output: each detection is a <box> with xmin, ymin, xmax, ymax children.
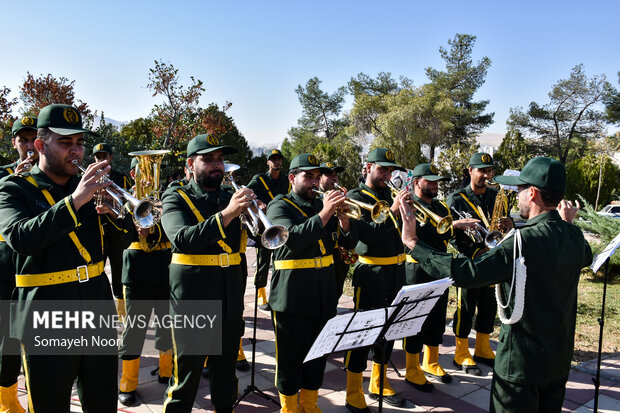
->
<box><xmin>0</xmin><ymin>116</ymin><xmax>39</xmax><ymax>413</ymax></box>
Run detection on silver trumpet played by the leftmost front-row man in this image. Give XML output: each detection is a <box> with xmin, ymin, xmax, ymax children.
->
<box><xmin>71</xmin><ymin>159</ymin><xmax>163</xmax><ymax>229</ymax></box>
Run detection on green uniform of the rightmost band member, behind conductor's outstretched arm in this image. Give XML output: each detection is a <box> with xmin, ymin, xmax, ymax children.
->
<box><xmin>446</xmin><ymin>158</ymin><xmax>497</xmax><ymax>338</ymax></box>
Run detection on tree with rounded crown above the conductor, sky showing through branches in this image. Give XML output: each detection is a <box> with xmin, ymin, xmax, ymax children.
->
<box><xmin>508</xmin><ymin>64</ymin><xmax>609</xmax><ymax>164</ymax></box>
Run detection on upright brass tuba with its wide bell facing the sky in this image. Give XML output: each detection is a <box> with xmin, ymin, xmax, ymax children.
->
<box><xmin>128</xmin><ymin>150</ymin><xmax>170</xmax><ymax>252</ymax></box>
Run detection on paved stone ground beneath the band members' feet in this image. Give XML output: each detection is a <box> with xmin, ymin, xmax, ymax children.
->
<box><xmin>13</xmin><ymin>248</ymin><xmax>620</xmax><ymax>413</ymax></box>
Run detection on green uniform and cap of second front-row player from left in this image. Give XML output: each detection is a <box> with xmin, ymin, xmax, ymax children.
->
<box><xmin>162</xmin><ymin>135</ymin><xmax>245</xmax><ymax>413</ymax></box>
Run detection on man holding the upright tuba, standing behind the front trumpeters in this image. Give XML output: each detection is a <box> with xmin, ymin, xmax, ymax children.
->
<box><xmin>118</xmin><ymin>158</ymin><xmax>172</xmax><ymax>406</ymax></box>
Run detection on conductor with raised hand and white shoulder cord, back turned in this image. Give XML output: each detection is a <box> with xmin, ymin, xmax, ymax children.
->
<box><xmin>401</xmin><ymin>157</ymin><xmax>592</xmax><ymax>412</ymax></box>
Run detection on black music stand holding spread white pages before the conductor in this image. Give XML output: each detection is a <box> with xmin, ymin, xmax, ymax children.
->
<box><xmin>305</xmin><ymin>281</ymin><xmax>452</xmax><ymax>413</ymax></box>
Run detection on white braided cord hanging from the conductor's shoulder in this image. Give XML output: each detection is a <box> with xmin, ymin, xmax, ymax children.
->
<box><xmin>495</xmin><ymin>229</ymin><xmax>527</xmax><ymax>324</ymax></box>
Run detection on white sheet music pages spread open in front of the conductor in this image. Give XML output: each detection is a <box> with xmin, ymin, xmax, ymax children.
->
<box><xmin>304</xmin><ymin>278</ymin><xmax>452</xmax><ymax>363</ymax></box>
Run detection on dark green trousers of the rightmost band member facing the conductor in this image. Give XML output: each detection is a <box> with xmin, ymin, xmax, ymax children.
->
<box><xmin>452</xmin><ymin>287</ymin><xmax>497</xmax><ymax>338</ymax></box>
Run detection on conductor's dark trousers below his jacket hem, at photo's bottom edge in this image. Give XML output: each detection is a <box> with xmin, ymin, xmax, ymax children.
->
<box><xmin>489</xmin><ymin>372</ymin><xmax>568</xmax><ymax>413</ymax></box>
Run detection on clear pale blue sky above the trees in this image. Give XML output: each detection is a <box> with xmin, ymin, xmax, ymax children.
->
<box><xmin>0</xmin><ymin>0</ymin><xmax>620</xmax><ymax>145</ymax></box>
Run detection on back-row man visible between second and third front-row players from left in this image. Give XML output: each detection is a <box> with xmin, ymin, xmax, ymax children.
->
<box><xmin>248</xmin><ymin>149</ymin><xmax>291</xmax><ymax>310</ymax></box>
